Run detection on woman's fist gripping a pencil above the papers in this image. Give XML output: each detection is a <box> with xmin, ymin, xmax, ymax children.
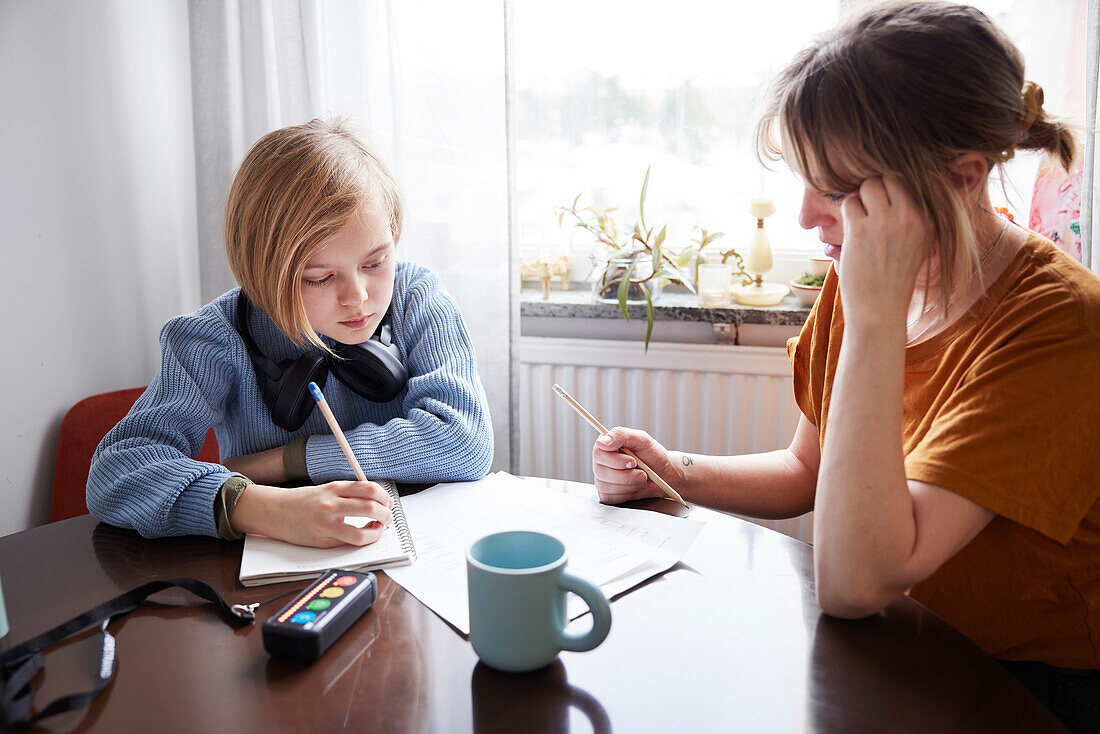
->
<box><xmin>592</xmin><ymin>427</ymin><xmax>679</xmax><ymax>505</ymax></box>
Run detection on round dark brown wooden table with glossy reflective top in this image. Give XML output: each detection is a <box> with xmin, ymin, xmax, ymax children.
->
<box><xmin>0</xmin><ymin>479</ymin><xmax>1062</xmax><ymax>734</ymax></box>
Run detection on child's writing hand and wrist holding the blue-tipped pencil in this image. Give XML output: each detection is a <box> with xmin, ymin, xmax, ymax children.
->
<box><xmin>229</xmin><ymin>481</ymin><xmax>393</xmax><ymax>548</ymax></box>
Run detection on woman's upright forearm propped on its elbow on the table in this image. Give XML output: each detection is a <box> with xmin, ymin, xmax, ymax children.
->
<box><xmin>814</xmin><ymin>325</ymin><xmax>916</xmax><ymax>617</ymax></box>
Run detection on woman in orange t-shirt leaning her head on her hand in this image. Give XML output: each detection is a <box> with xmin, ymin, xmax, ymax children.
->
<box><xmin>593</xmin><ymin>2</ymin><xmax>1100</xmax><ymax>728</ymax></box>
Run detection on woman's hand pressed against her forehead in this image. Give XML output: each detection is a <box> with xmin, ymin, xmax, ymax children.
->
<box><xmin>839</xmin><ymin>175</ymin><xmax>934</xmax><ymax>325</ymax></box>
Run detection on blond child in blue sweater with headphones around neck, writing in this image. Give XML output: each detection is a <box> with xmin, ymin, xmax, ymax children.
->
<box><xmin>88</xmin><ymin>119</ymin><xmax>493</xmax><ymax>547</ymax></box>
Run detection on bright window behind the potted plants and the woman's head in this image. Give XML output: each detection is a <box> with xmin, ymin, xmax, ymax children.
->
<box><xmin>513</xmin><ymin>0</ymin><xmax>1087</xmax><ymax>272</ymax></box>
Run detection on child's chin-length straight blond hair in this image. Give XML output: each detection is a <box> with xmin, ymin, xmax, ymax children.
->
<box><xmin>226</xmin><ymin>118</ymin><xmax>404</xmax><ymax>349</ymax></box>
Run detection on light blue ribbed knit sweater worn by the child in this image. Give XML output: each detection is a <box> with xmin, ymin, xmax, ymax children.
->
<box><xmin>88</xmin><ymin>262</ymin><xmax>493</xmax><ymax>537</ymax></box>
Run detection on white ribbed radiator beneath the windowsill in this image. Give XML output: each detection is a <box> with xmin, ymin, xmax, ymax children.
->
<box><xmin>519</xmin><ymin>337</ymin><xmax>813</xmax><ymax>543</ymax></box>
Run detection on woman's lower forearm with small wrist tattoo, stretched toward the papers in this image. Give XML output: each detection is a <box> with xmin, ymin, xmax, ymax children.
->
<box><xmin>671</xmin><ymin>449</ymin><xmax>815</xmax><ymax>518</ymax></box>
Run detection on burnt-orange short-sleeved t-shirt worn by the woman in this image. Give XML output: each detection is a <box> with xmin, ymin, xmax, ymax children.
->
<box><xmin>787</xmin><ymin>234</ymin><xmax>1100</xmax><ymax>669</ymax></box>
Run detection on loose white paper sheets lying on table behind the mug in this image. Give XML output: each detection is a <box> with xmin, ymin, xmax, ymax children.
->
<box><xmin>386</xmin><ymin>472</ymin><xmax>703</xmax><ymax>634</ymax></box>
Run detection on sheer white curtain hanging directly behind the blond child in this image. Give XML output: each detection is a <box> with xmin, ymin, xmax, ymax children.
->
<box><xmin>189</xmin><ymin>0</ymin><xmax>518</xmax><ymax>469</ymax></box>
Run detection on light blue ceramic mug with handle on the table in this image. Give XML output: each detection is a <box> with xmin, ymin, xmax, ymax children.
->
<box><xmin>466</xmin><ymin>530</ymin><xmax>612</xmax><ymax>672</ymax></box>
